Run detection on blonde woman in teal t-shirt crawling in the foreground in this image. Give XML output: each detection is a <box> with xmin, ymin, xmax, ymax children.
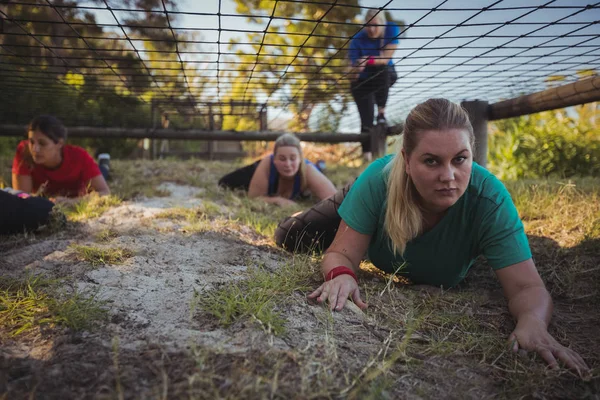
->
<box><xmin>276</xmin><ymin>99</ymin><xmax>588</xmax><ymax>374</ymax></box>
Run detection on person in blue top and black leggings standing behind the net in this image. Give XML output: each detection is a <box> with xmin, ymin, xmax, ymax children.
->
<box><xmin>348</xmin><ymin>9</ymin><xmax>400</xmax><ymax>162</ymax></box>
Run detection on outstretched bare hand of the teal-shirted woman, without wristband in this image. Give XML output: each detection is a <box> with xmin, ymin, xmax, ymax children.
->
<box><xmin>509</xmin><ymin>316</ymin><xmax>590</xmax><ymax>377</ymax></box>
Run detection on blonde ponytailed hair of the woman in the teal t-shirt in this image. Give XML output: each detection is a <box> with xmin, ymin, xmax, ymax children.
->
<box><xmin>384</xmin><ymin>99</ymin><xmax>475</xmax><ymax>255</ymax></box>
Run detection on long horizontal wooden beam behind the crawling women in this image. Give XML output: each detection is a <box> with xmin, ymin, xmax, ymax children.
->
<box><xmin>0</xmin><ymin>125</ymin><xmax>369</xmax><ymax>143</ymax></box>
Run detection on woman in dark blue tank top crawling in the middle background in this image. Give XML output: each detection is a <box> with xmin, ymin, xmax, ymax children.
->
<box><xmin>219</xmin><ymin>133</ymin><xmax>336</xmax><ymax>206</ymax></box>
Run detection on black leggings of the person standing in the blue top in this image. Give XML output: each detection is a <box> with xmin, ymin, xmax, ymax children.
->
<box><xmin>350</xmin><ymin>65</ymin><xmax>395</xmax><ymax>152</ymax></box>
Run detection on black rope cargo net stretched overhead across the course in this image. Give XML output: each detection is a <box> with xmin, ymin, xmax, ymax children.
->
<box><xmin>0</xmin><ymin>0</ymin><xmax>600</xmax><ymax>132</ymax></box>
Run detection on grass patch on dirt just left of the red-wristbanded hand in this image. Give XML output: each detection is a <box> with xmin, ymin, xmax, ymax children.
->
<box><xmin>199</xmin><ymin>258</ymin><xmax>317</xmax><ymax>335</ymax></box>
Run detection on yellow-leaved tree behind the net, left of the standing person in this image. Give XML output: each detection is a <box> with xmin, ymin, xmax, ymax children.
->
<box><xmin>232</xmin><ymin>0</ymin><xmax>361</xmax><ymax>131</ymax></box>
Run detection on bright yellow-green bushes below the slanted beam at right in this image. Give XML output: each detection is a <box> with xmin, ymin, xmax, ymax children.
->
<box><xmin>489</xmin><ymin>103</ymin><xmax>600</xmax><ymax>180</ymax></box>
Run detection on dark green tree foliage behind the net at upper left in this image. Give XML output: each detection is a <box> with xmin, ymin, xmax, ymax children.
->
<box><xmin>0</xmin><ymin>0</ymin><xmax>201</xmax><ymax>157</ymax></box>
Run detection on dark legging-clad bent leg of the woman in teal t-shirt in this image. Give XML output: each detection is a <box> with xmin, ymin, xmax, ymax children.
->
<box><xmin>275</xmin><ymin>182</ymin><xmax>354</xmax><ymax>253</ymax></box>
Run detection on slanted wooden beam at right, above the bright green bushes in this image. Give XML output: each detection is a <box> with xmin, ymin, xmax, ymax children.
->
<box><xmin>488</xmin><ymin>76</ymin><xmax>600</xmax><ymax>121</ymax></box>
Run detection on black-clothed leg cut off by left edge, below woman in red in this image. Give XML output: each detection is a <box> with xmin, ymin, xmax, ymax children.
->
<box><xmin>0</xmin><ymin>190</ymin><xmax>54</xmax><ymax>235</ymax></box>
